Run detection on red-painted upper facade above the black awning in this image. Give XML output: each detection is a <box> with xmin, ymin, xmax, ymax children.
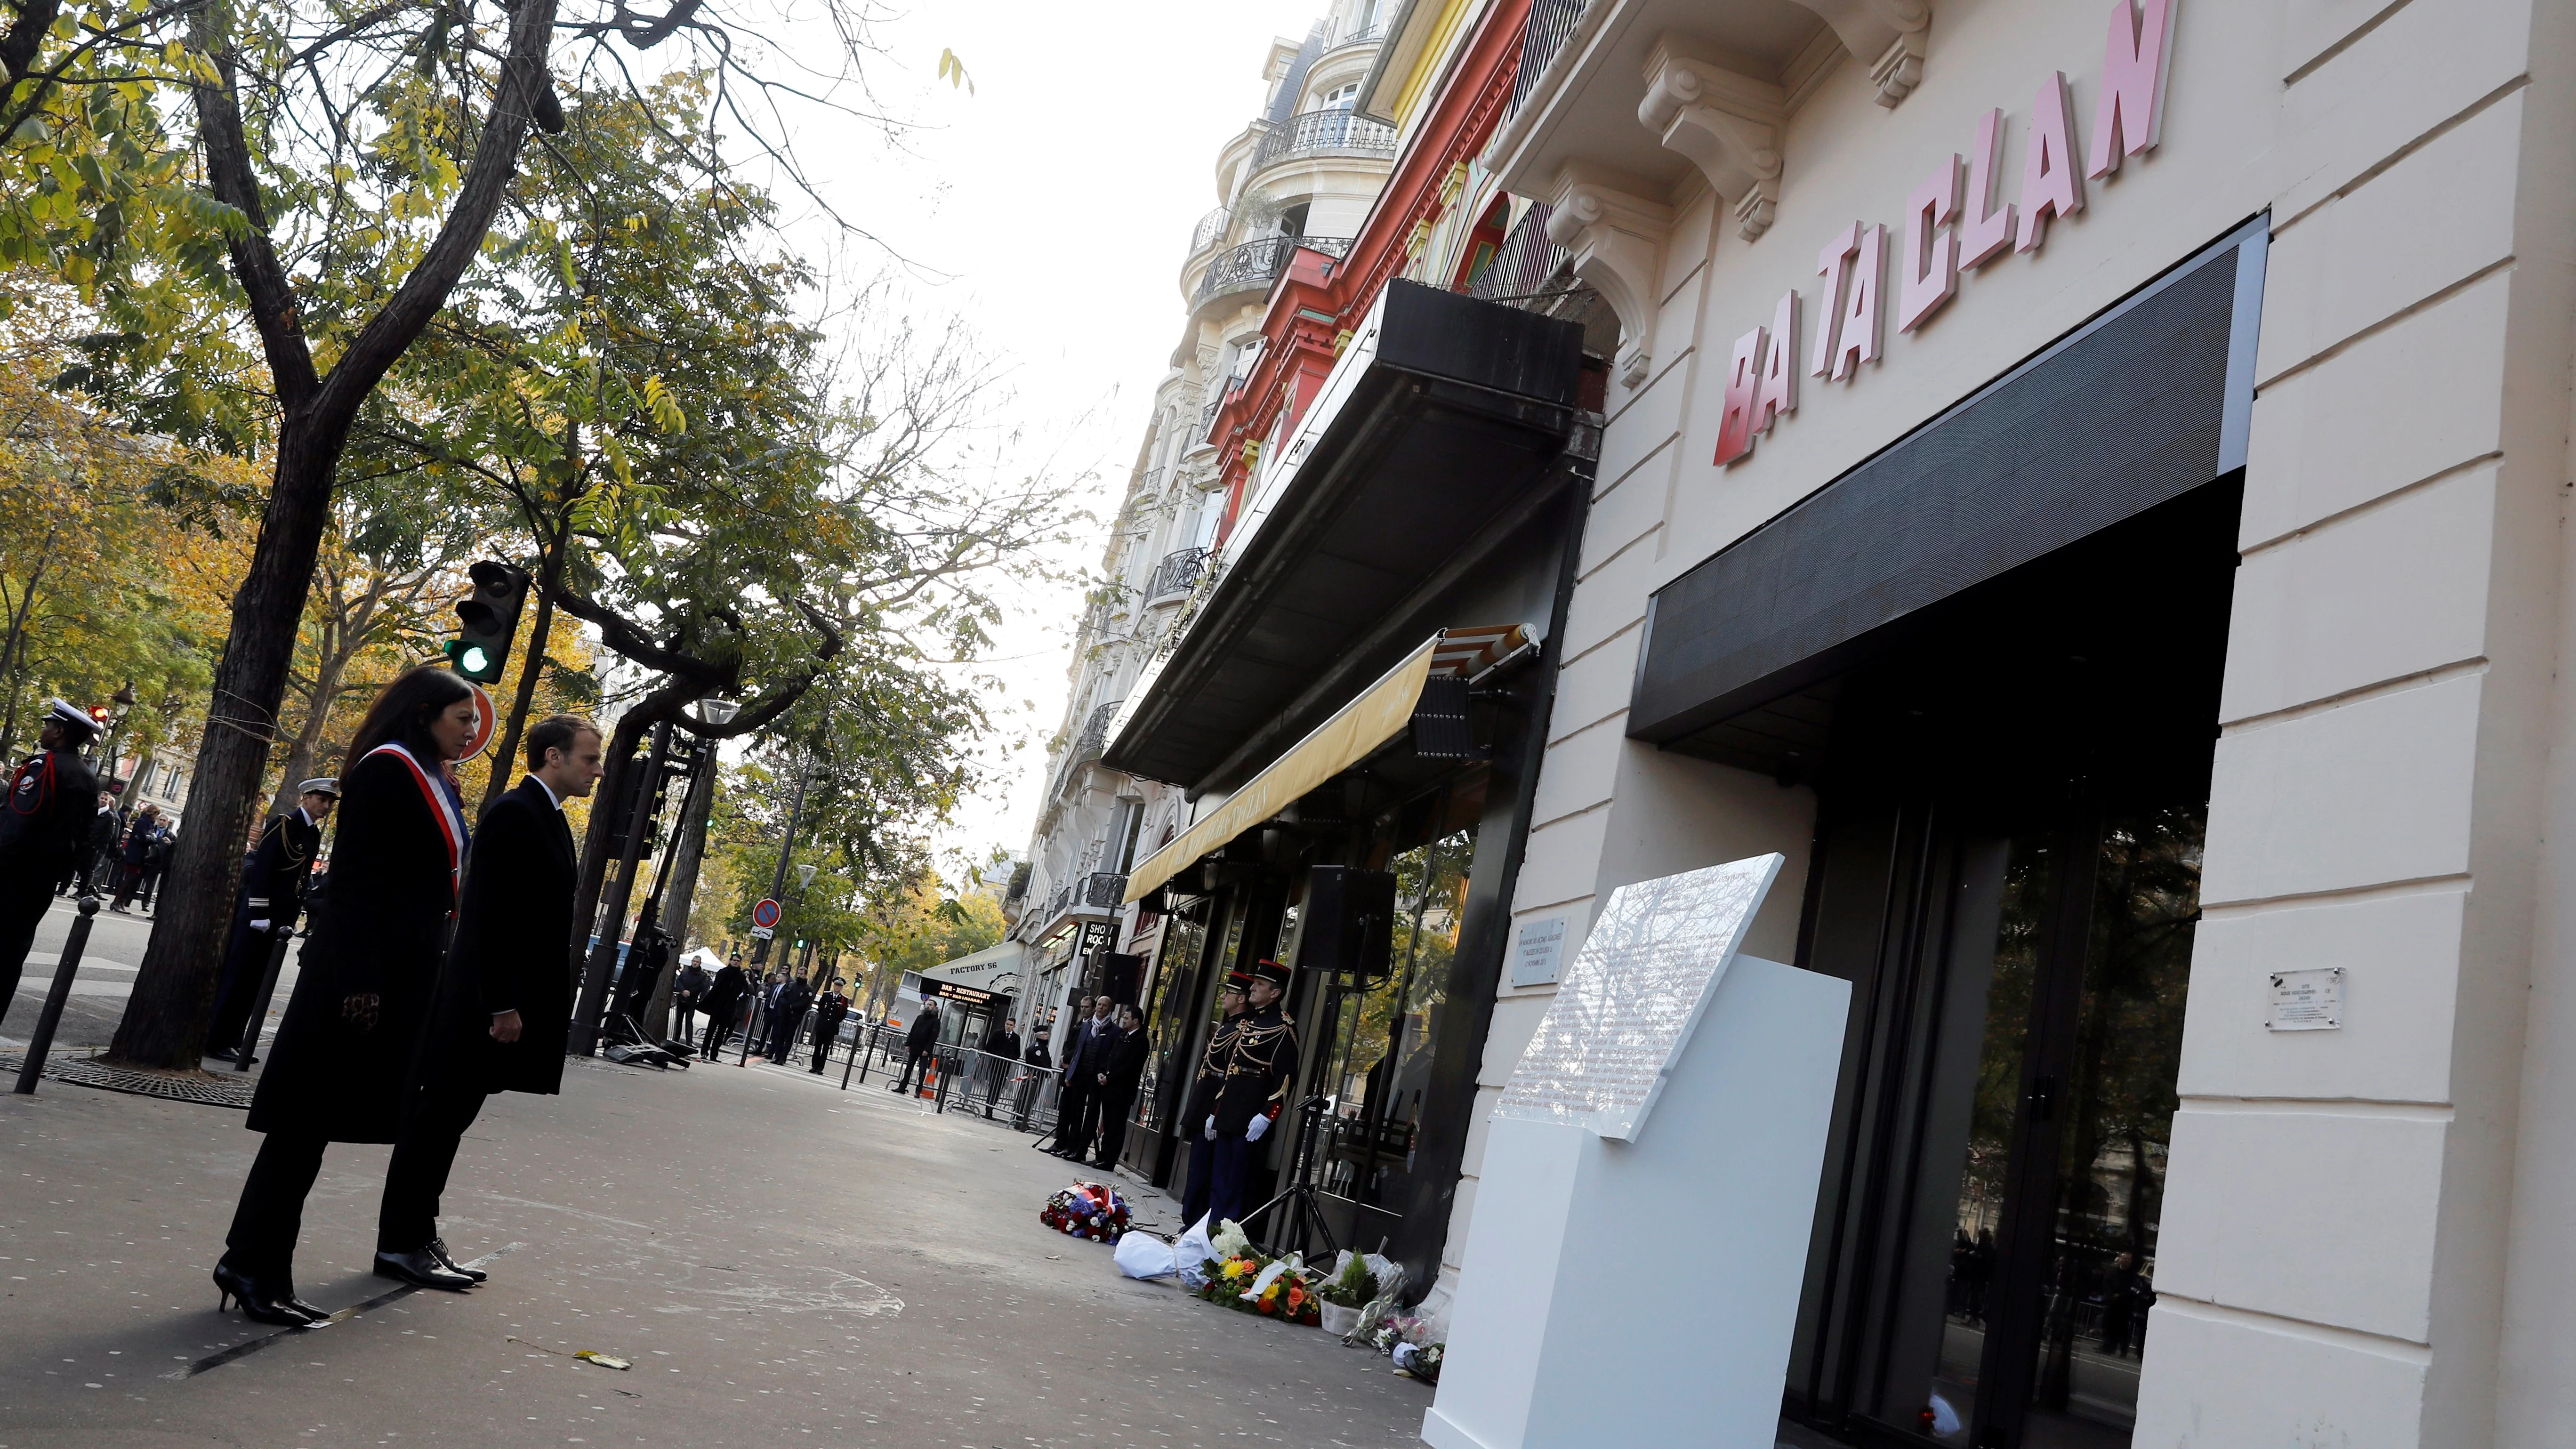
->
<box><xmin>1208</xmin><ymin>0</ymin><xmax>1530</xmax><ymax>541</ymax></box>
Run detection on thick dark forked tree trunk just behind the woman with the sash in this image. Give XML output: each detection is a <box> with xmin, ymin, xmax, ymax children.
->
<box><xmin>108</xmin><ymin>0</ymin><xmax>556</xmax><ymax>1067</ymax></box>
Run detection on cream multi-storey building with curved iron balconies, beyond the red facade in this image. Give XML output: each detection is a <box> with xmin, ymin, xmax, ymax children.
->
<box><xmin>1005</xmin><ymin>0</ymin><xmax>1396</xmax><ymax>1062</ymax></box>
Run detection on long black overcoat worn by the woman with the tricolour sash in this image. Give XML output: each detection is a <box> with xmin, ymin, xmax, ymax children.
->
<box><xmin>250</xmin><ymin>753</ymin><xmax>456</xmax><ymax>1142</ymax></box>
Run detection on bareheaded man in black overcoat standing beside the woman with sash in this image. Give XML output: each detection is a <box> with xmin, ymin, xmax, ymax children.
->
<box><xmin>376</xmin><ymin>714</ymin><xmax>600</xmax><ymax>1281</ymax></box>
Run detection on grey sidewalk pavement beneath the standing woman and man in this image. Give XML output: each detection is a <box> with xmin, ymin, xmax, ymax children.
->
<box><xmin>0</xmin><ymin>1031</ymin><xmax>1430</xmax><ymax>1449</ymax></box>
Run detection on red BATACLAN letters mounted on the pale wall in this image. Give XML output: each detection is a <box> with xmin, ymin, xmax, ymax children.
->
<box><xmin>1713</xmin><ymin>0</ymin><xmax>2174</xmax><ymax>467</ymax></box>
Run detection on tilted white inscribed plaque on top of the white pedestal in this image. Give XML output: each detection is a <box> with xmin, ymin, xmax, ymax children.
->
<box><xmin>1494</xmin><ymin>856</ymin><xmax>1783</xmax><ymax>1142</ymax></box>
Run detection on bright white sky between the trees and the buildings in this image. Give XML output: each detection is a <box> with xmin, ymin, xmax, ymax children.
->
<box><xmin>747</xmin><ymin>0</ymin><xmax>1324</xmax><ymax>882</ymax></box>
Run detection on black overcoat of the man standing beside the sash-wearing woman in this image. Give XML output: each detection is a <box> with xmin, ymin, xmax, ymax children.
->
<box><xmin>422</xmin><ymin>776</ymin><xmax>580</xmax><ymax>1093</ymax></box>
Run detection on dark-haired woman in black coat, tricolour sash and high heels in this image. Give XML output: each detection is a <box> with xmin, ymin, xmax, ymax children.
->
<box><xmin>214</xmin><ymin>665</ymin><xmax>479</xmax><ymax>1325</ymax></box>
